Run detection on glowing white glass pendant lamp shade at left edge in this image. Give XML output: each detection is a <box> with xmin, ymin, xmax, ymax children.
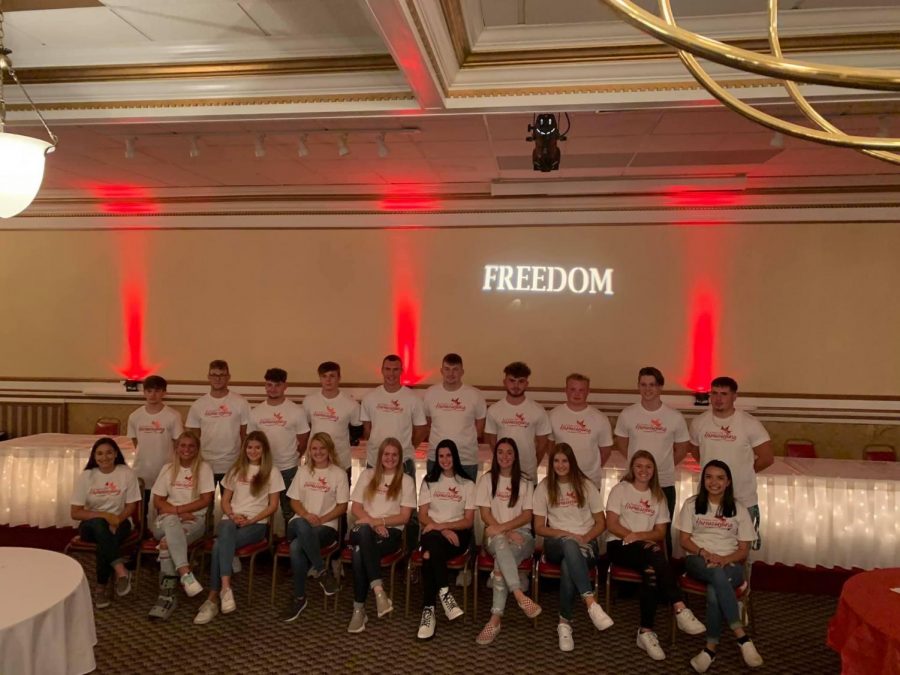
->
<box><xmin>0</xmin><ymin>132</ymin><xmax>54</xmax><ymax>218</ymax></box>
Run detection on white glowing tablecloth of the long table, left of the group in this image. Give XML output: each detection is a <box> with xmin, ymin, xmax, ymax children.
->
<box><xmin>0</xmin><ymin>434</ymin><xmax>134</xmax><ymax>532</ymax></box>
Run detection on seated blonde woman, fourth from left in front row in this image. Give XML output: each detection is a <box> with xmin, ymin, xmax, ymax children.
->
<box><xmin>282</xmin><ymin>431</ymin><xmax>350</xmax><ymax>623</ymax></box>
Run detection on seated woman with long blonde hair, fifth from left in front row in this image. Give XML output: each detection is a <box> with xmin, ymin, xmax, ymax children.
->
<box><xmin>347</xmin><ymin>437</ymin><xmax>416</xmax><ymax>633</ymax></box>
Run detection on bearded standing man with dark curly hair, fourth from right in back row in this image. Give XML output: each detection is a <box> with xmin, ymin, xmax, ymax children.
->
<box><xmin>484</xmin><ymin>361</ymin><xmax>550</xmax><ymax>482</ymax></box>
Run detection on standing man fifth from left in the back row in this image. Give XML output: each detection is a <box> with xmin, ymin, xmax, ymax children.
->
<box><xmin>359</xmin><ymin>354</ymin><xmax>428</xmax><ymax>480</ymax></box>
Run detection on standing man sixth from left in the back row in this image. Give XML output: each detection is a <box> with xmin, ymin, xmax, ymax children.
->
<box><xmin>425</xmin><ymin>353</ymin><xmax>487</xmax><ymax>481</ymax></box>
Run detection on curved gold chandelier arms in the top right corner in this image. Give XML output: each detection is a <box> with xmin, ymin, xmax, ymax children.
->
<box><xmin>600</xmin><ymin>0</ymin><xmax>900</xmax><ymax>164</ymax></box>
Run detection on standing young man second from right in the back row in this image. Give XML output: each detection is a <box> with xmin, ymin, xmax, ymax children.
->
<box><xmin>615</xmin><ymin>366</ymin><xmax>691</xmax><ymax>553</ymax></box>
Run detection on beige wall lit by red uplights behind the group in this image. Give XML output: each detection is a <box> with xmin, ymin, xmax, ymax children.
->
<box><xmin>0</xmin><ymin>219</ymin><xmax>900</xmax><ymax>396</ymax></box>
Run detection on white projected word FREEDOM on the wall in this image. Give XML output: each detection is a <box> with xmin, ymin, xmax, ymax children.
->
<box><xmin>481</xmin><ymin>265</ymin><xmax>613</xmax><ymax>295</ymax></box>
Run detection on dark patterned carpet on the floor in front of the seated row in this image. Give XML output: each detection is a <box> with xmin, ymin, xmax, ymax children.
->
<box><xmin>77</xmin><ymin>556</ymin><xmax>840</xmax><ymax>675</ymax></box>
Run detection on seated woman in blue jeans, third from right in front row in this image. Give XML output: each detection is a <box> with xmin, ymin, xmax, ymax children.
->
<box><xmin>534</xmin><ymin>443</ymin><xmax>613</xmax><ymax>652</ymax></box>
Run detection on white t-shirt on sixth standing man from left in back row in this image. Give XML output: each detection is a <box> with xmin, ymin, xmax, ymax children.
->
<box><xmin>425</xmin><ymin>384</ymin><xmax>487</xmax><ymax>465</ymax></box>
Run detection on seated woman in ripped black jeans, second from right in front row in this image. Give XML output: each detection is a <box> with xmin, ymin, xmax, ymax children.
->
<box><xmin>606</xmin><ymin>450</ymin><xmax>706</xmax><ymax>661</ymax></box>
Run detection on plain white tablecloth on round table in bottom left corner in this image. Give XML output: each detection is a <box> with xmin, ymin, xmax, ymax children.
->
<box><xmin>0</xmin><ymin>547</ymin><xmax>97</xmax><ymax>675</ymax></box>
